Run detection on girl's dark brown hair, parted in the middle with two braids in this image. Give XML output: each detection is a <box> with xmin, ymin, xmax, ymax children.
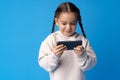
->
<box><xmin>51</xmin><ymin>2</ymin><xmax>86</xmax><ymax>37</ymax></box>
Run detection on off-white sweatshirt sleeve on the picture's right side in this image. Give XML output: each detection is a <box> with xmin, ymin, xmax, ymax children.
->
<box><xmin>77</xmin><ymin>41</ymin><xmax>96</xmax><ymax>71</ymax></box>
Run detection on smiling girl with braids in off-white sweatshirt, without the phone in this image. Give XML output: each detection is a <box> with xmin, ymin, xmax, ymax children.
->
<box><xmin>38</xmin><ymin>2</ymin><xmax>96</xmax><ymax>80</ymax></box>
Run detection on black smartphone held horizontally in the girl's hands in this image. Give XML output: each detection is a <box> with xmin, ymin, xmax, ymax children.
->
<box><xmin>57</xmin><ymin>40</ymin><xmax>82</xmax><ymax>50</ymax></box>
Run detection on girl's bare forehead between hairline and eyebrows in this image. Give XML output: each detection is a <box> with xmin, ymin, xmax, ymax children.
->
<box><xmin>58</xmin><ymin>12</ymin><xmax>77</xmax><ymax>21</ymax></box>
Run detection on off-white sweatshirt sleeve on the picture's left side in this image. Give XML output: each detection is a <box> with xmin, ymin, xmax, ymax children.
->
<box><xmin>38</xmin><ymin>35</ymin><xmax>59</xmax><ymax>72</ymax></box>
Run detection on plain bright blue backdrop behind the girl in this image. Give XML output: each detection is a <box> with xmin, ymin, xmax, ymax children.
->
<box><xmin>0</xmin><ymin>0</ymin><xmax>120</xmax><ymax>80</ymax></box>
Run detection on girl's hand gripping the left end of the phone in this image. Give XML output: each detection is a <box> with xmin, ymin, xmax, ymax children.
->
<box><xmin>53</xmin><ymin>44</ymin><xmax>67</xmax><ymax>56</ymax></box>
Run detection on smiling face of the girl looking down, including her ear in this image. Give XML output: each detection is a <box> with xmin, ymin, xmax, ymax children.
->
<box><xmin>55</xmin><ymin>12</ymin><xmax>77</xmax><ymax>37</ymax></box>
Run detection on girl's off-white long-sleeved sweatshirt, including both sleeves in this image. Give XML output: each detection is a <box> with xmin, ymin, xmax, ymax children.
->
<box><xmin>38</xmin><ymin>31</ymin><xmax>96</xmax><ymax>80</ymax></box>
